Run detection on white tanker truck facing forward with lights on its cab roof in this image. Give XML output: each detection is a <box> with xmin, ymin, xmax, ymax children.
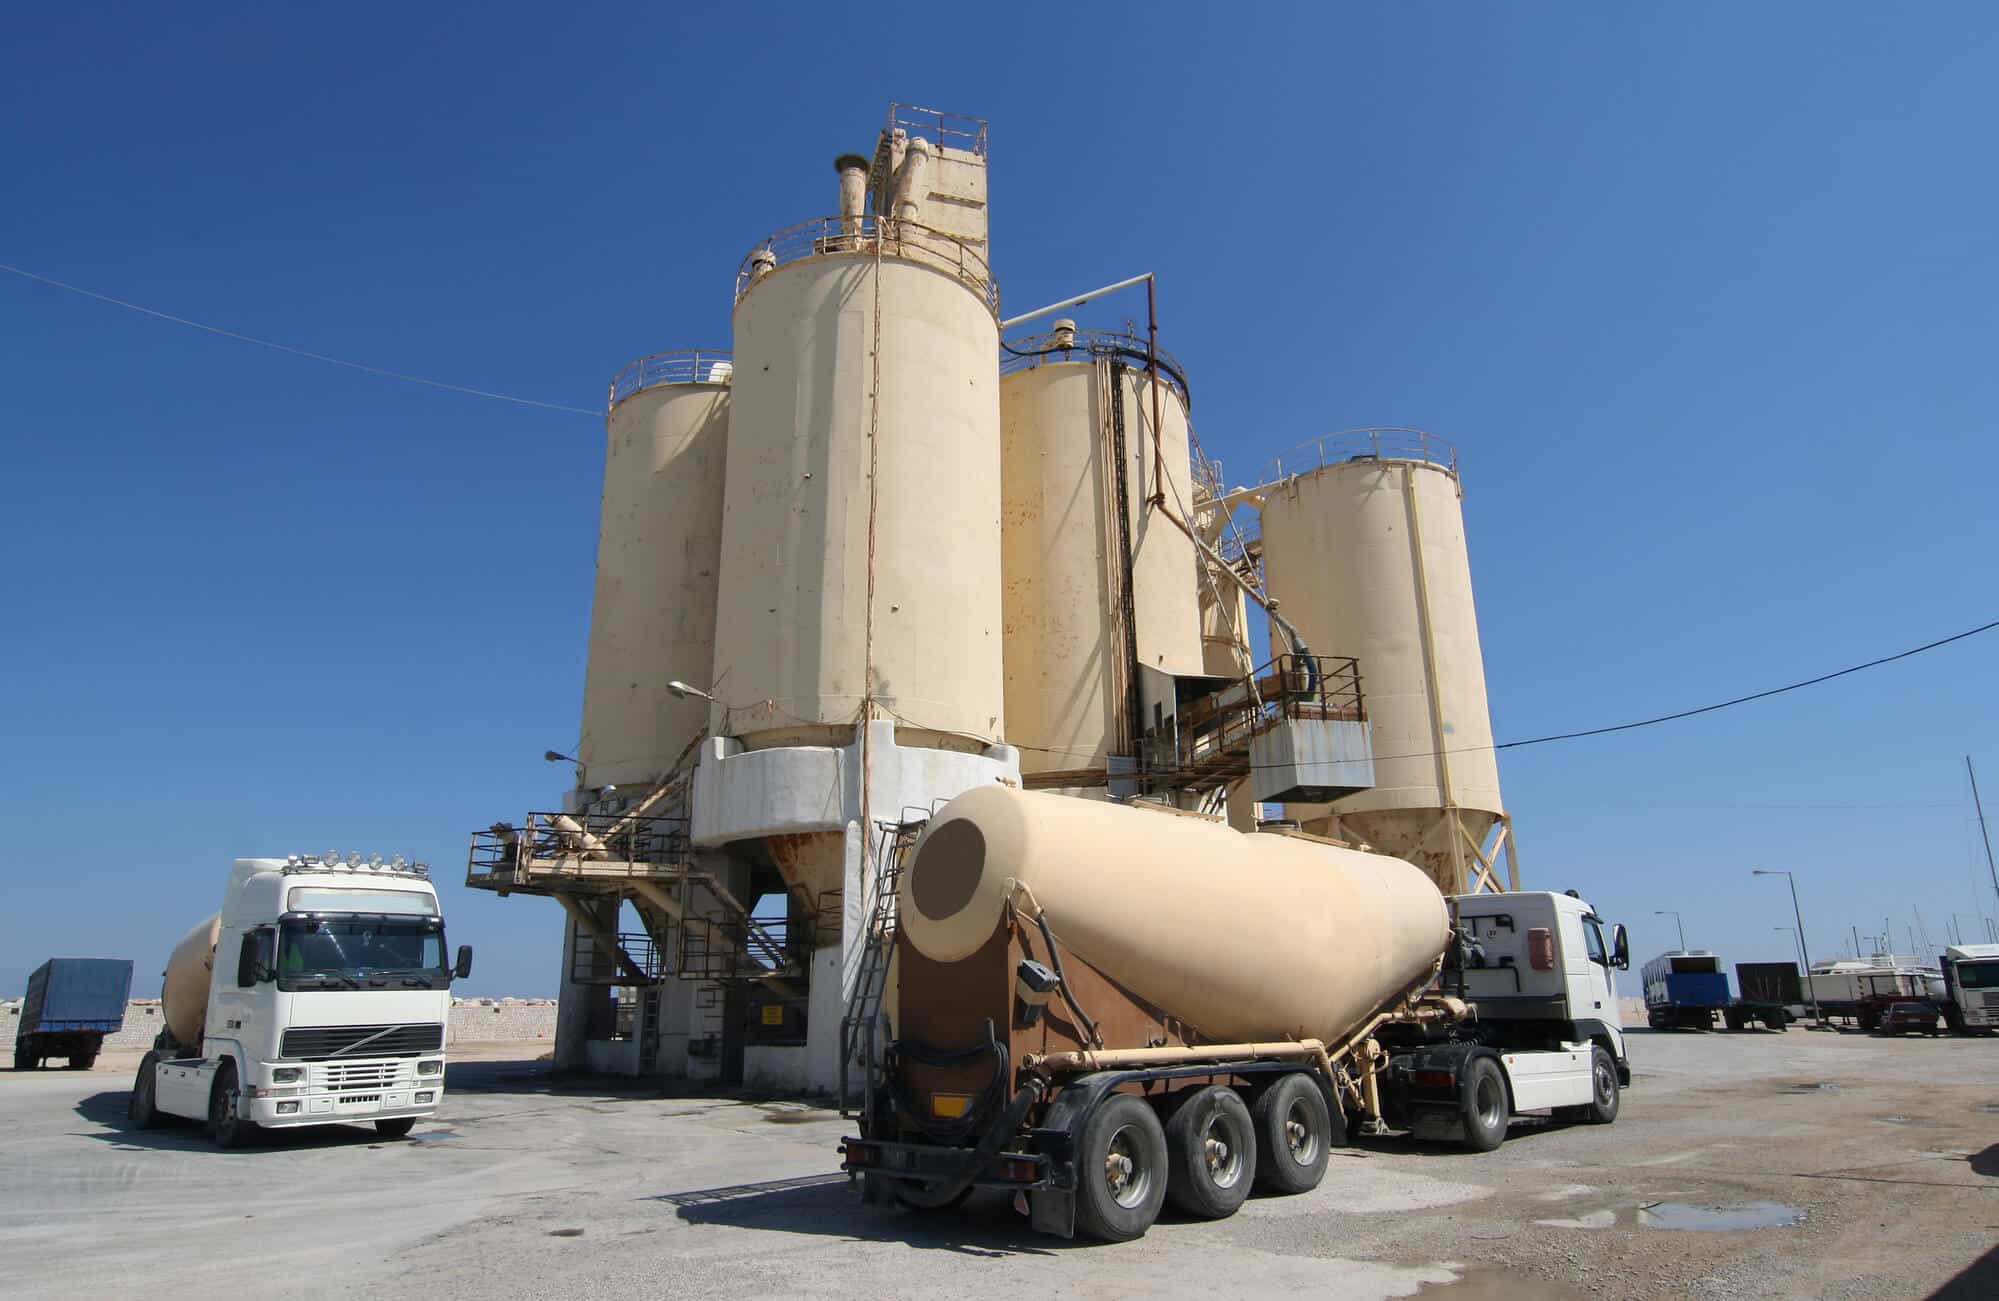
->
<box><xmin>130</xmin><ymin>853</ymin><xmax>472</xmax><ymax>1147</ymax></box>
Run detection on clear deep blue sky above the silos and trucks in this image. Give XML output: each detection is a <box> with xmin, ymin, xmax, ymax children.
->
<box><xmin>0</xmin><ymin>4</ymin><xmax>1999</xmax><ymax>995</ymax></box>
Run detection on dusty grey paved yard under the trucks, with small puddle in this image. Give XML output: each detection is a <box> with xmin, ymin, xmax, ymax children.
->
<box><xmin>0</xmin><ymin>1029</ymin><xmax>1999</xmax><ymax>1301</ymax></box>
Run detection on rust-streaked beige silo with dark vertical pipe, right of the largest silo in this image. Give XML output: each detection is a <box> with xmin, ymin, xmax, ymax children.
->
<box><xmin>1000</xmin><ymin>335</ymin><xmax>1203</xmax><ymax>787</ymax></box>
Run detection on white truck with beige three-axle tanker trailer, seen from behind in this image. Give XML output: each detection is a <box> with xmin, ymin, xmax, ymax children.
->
<box><xmin>842</xmin><ymin>787</ymin><xmax>1629</xmax><ymax>1241</ymax></box>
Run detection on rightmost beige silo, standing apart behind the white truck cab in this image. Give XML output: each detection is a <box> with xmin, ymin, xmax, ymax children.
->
<box><xmin>1261</xmin><ymin>430</ymin><xmax>1505</xmax><ymax>893</ymax></box>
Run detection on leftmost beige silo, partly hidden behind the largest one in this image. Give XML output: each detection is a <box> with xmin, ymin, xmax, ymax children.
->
<box><xmin>578</xmin><ymin>352</ymin><xmax>732</xmax><ymax>787</ymax></box>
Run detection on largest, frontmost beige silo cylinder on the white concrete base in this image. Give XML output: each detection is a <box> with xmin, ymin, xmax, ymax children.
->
<box><xmin>712</xmin><ymin>216</ymin><xmax>1005</xmax><ymax>751</ymax></box>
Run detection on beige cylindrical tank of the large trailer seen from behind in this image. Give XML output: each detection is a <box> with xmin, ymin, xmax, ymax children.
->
<box><xmin>900</xmin><ymin>787</ymin><xmax>1449</xmax><ymax>1043</ymax></box>
